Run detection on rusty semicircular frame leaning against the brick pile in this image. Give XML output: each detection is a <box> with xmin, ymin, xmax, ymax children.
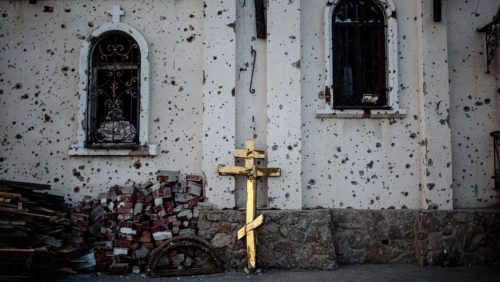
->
<box><xmin>148</xmin><ymin>235</ymin><xmax>224</xmax><ymax>277</ymax></box>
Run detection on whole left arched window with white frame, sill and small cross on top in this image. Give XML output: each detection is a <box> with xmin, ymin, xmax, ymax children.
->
<box><xmin>69</xmin><ymin>6</ymin><xmax>154</xmax><ymax>156</ymax></box>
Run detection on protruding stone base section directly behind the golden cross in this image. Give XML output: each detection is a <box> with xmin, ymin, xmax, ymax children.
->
<box><xmin>198</xmin><ymin>210</ymin><xmax>338</xmax><ymax>270</ymax></box>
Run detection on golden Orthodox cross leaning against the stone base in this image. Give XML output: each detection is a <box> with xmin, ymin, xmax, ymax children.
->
<box><xmin>219</xmin><ymin>140</ymin><xmax>281</xmax><ymax>272</ymax></box>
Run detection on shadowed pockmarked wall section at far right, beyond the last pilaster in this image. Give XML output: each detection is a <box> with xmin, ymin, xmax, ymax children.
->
<box><xmin>447</xmin><ymin>0</ymin><xmax>500</xmax><ymax>208</ymax></box>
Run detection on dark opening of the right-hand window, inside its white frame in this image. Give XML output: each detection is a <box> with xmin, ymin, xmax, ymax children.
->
<box><xmin>332</xmin><ymin>0</ymin><xmax>389</xmax><ymax>109</ymax></box>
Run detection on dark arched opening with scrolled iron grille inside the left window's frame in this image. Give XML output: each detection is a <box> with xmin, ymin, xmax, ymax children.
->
<box><xmin>85</xmin><ymin>32</ymin><xmax>141</xmax><ymax>148</ymax></box>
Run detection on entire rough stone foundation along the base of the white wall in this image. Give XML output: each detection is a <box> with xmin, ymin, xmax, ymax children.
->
<box><xmin>198</xmin><ymin>209</ymin><xmax>500</xmax><ymax>270</ymax></box>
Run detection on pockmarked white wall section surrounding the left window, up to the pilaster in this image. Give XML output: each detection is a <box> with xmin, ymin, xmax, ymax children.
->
<box><xmin>0</xmin><ymin>0</ymin><xmax>203</xmax><ymax>201</ymax></box>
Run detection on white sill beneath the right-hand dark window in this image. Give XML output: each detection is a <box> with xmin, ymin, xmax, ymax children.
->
<box><xmin>316</xmin><ymin>109</ymin><xmax>406</xmax><ymax>118</ymax></box>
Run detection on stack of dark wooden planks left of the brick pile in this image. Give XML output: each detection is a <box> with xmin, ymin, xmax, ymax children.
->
<box><xmin>0</xmin><ymin>181</ymin><xmax>78</xmax><ymax>281</ymax></box>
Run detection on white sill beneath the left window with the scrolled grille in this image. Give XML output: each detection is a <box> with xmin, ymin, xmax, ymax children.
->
<box><xmin>69</xmin><ymin>144</ymin><xmax>158</xmax><ymax>156</ymax></box>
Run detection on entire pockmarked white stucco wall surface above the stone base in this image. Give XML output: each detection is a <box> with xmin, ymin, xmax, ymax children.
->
<box><xmin>0</xmin><ymin>0</ymin><xmax>500</xmax><ymax>209</ymax></box>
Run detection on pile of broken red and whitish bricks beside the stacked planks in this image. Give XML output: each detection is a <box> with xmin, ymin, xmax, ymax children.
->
<box><xmin>71</xmin><ymin>171</ymin><xmax>210</xmax><ymax>275</ymax></box>
